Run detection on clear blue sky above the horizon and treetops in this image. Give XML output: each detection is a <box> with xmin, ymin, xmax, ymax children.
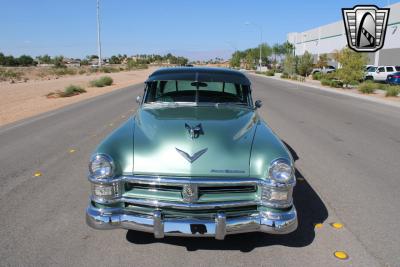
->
<box><xmin>0</xmin><ymin>0</ymin><xmax>398</xmax><ymax>59</ymax></box>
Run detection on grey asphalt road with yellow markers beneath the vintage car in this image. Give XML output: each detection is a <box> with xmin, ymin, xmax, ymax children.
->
<box><xmin>0</xmin><ymin>76</ymin><xmax>400</xmax><ymax>266</ymax></box>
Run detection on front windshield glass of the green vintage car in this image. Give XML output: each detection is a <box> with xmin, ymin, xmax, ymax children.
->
<box><xmin>145</xmin><ymin>80</ymin><xmax>251</xmax><ymax>105</ymax></box>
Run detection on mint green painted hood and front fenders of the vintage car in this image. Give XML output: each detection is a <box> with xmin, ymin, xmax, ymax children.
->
<box><xmin>95</xmin><ymin>106</ymin><xmax>291</xmax><ymax>178</ymax></box>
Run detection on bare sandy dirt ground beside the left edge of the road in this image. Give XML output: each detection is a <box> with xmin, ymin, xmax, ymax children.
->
<box><xmin>0</xmin><ymin>67</ymin><xmax>156</xmax><ymax>126</ymax></box>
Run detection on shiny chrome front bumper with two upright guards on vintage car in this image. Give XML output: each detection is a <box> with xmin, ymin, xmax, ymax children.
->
<box><xmin>86</xmin><ymin>204</ymin><xmax>297</xmax><ymax>240</ymax></box>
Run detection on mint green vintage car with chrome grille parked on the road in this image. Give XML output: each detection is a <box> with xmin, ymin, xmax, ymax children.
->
<box><xmin>86</xmin><ymin>67</ymin><xmax>297</xmax><ymax>239</ymax></box>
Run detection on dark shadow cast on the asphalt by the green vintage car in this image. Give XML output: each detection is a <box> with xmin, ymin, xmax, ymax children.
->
<box><xmin>126</xmin><ymin>142</ymin><xmax>328</xmax><ymax>252</ymax></box>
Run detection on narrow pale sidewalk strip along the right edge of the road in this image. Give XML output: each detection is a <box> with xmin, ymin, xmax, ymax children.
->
<box><xmin>249</xmin><ymin>73</ymin><xmax>400</xmax><ymax>108</ymax></box>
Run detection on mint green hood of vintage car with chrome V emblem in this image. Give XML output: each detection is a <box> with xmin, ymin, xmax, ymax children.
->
<box><xmin>133</xmin><ymin>105</ymin><xmax>259</xmax><ymax>177</ymax></box>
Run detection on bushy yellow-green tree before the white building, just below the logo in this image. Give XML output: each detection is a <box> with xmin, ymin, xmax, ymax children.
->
<box><xmin>337</xmin><ymin>48</ymin><xmax>367</xmax><ymax>87</ymax></box>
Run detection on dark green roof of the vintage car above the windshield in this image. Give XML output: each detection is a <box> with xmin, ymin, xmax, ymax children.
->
<box><xmin>146</xmin><ymin>67</ymin><xmax>251</xmax><ymax>85</ymax></box>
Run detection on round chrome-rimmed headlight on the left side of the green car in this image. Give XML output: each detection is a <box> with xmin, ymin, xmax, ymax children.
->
<box><xmin>89</xmin><ymin>154</ymin><xmax>114</xmax><ymax>179</ymax></box>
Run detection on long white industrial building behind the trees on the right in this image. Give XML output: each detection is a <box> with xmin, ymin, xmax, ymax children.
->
<box><xmin>287</xmin><ymin>3</ymin><xmax>400</xmax><ymax>66</ymax></box>
